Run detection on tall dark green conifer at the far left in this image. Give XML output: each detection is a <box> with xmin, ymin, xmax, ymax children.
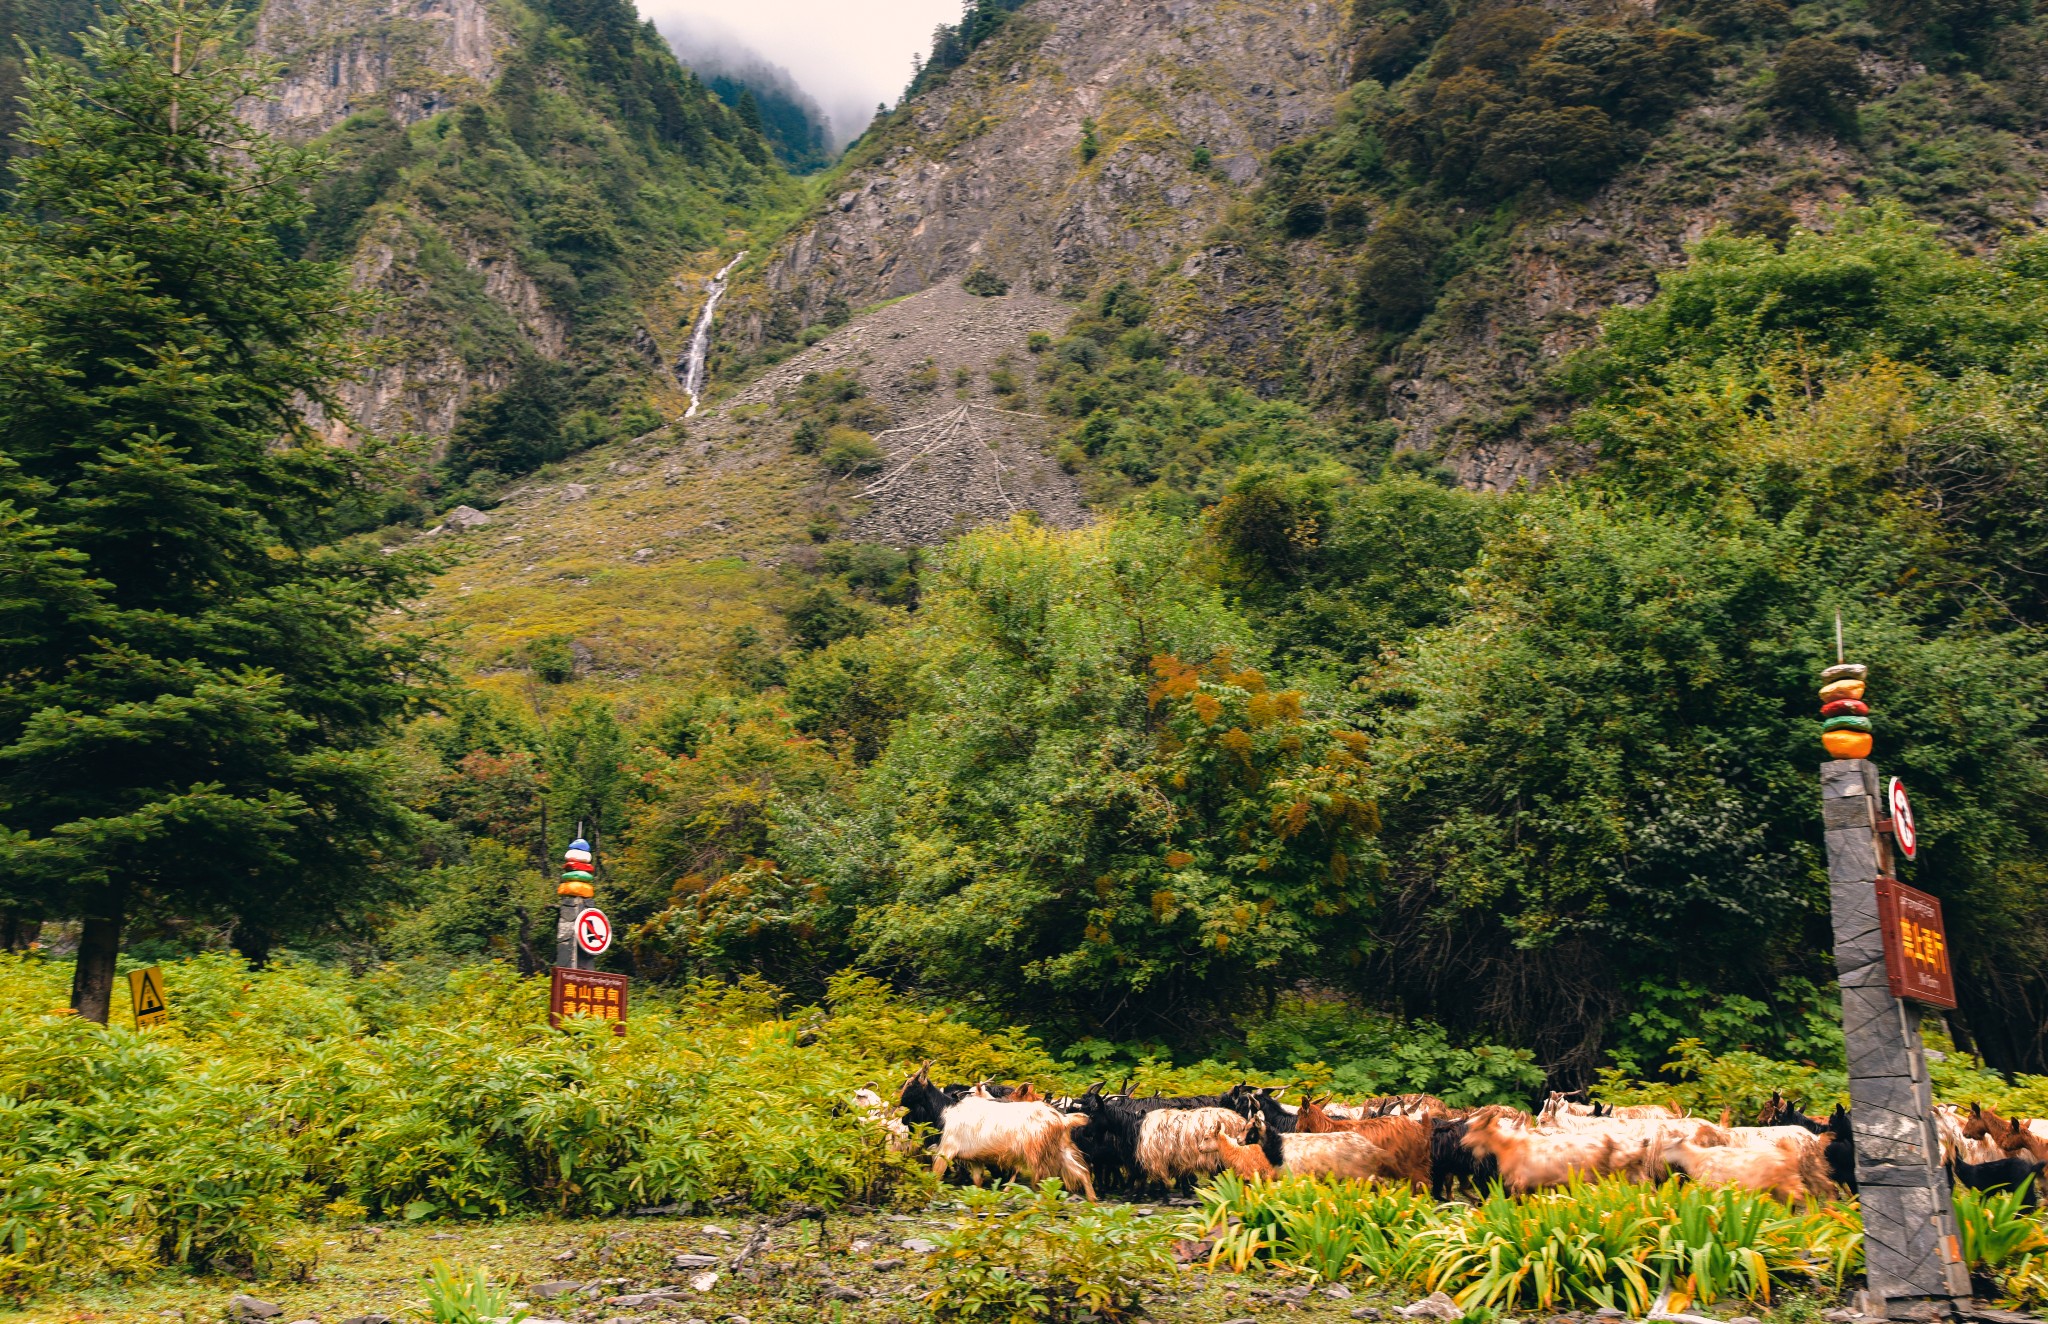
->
<box><xmin>0</xmin><ymin>0</ymin><xmax>444</xmax><ymax>1021</ymax></box>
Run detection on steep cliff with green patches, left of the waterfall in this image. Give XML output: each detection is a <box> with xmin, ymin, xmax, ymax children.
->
<box><xmin>248</xmin><ymin>0</ymin><xmax>795</xmax><ymax>467</ymax></box>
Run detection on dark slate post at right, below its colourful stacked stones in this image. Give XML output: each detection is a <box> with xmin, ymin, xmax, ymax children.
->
<box><xmin>1821</xmin><ymin>758</ymin><xmax>1970</xmax><ymax>1320</ymax></box>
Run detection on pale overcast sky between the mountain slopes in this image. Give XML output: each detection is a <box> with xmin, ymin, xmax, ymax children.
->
<box><xmin>637</xmin><ymin>0</ymin><xmax>961</xmax><ymax>145</ymax></box>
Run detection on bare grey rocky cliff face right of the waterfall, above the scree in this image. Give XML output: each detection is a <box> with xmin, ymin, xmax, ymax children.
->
<box><xmin>731</xmin><ymin>0</ymin><xmax>1348</xmax><ymax>342</ymax></box>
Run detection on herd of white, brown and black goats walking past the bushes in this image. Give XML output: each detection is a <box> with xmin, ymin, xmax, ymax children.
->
<box><xmin>856</xmin><ymin>1064</ymin><xmax>2048</xmax><ymax>1205</ymax></box>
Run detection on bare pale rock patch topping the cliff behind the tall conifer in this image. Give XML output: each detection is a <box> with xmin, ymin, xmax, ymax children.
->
<box><xmin>248</xmin><ymin>0</ymin><xmax>512</xmax><ymax>137</ymax></box>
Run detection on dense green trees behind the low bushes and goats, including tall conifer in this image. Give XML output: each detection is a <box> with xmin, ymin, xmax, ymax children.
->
<box><xmin>0</xmin><ymin>4</ymin><xmax>2048</xmax><ymax>1123</ymax></box>
